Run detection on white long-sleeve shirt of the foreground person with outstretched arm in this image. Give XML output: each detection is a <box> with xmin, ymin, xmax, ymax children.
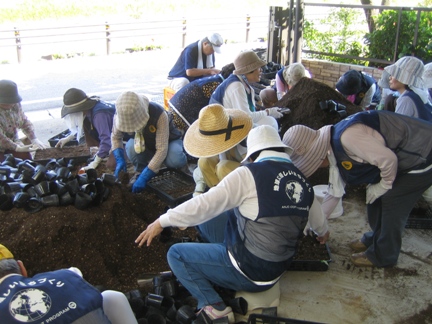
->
<box><xmin>159</xmin><ymin>151</ymin><xmax>328</xmax><ymax>236</ymax></box>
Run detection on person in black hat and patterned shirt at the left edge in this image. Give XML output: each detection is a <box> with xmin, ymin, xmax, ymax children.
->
<box><xmin>0</xmin><ymin>80</ymin><xmax>47</xmax><ymax>162</ymax></box>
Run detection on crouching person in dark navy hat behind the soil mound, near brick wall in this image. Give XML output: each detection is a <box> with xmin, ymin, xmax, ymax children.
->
<box><xmin>336</xmin><ymin>70</ymin><xmax>381</xmax><ymax>110</ymax></box>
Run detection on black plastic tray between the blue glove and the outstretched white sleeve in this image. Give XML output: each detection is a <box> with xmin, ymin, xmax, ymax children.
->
<box><xmin>147</xmin><ymin>168</ymin><xmax>195</xmax><ymax>207</ymax></box>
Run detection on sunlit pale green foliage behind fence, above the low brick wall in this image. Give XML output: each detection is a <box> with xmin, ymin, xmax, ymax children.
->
<box><xmin>303</xmin><ymin>8</ymin><xmax>366</xmax><ymax>65</ymax></box>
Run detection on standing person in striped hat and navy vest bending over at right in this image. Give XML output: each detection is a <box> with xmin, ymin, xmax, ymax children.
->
<box><xmin>283</xmin><ymin>110</ymin><xmax>432</xmax><ymax>267</ymax></box>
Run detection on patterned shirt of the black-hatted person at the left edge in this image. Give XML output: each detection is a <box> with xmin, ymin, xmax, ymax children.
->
<box><xmin>0</xmin><ymin>103</ymin><xmax>36</xmax><ymax>152</ymax></box>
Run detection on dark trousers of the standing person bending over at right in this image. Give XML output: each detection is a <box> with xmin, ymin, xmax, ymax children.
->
<box><xmin>362</xmin><ymin>170</ymin><xmax>432</xmax><ymax>267</ymax></box>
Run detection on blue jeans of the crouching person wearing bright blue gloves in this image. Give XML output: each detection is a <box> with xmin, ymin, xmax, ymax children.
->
<box><xmin>125</xmin><ymin>138</ymin><xmax>187</xmax><ymax>172</ymax></box>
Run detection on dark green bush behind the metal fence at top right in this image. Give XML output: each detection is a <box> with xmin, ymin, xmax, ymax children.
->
<box><xmin>365</xmin><ymin>10</ymin><xmax>432</xmax><ymax>63</ymax></box>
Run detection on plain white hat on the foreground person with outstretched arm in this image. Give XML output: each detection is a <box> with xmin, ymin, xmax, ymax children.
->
<box><xmin>242</xmin><ymin>125</ymin><xmax>292</xmax><ymax>162</ymax></box>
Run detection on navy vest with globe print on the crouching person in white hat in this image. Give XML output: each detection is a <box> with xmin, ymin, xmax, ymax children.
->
<box><xmin>225</xmin><ymin>160</ymin><xmax>314</xmax><ymax>281</ymax></box>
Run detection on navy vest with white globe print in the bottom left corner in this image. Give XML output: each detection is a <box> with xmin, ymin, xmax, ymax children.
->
<box><xmin>0</xmin><ymin>269</ymin><xmax>110</xmax><ymax>324</ymax></box>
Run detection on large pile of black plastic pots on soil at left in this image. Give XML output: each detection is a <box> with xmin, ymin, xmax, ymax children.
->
<box><xmin>0</xmin><ymin>154</ymin><xmax>116</xmax><ymax>213</ymax></box>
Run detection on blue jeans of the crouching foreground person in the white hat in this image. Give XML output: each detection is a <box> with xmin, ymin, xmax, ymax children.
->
<box><xmin>167</xmin><ymin>213</ymin><xmax>271</xmax><ymax>308</ymax></box>
